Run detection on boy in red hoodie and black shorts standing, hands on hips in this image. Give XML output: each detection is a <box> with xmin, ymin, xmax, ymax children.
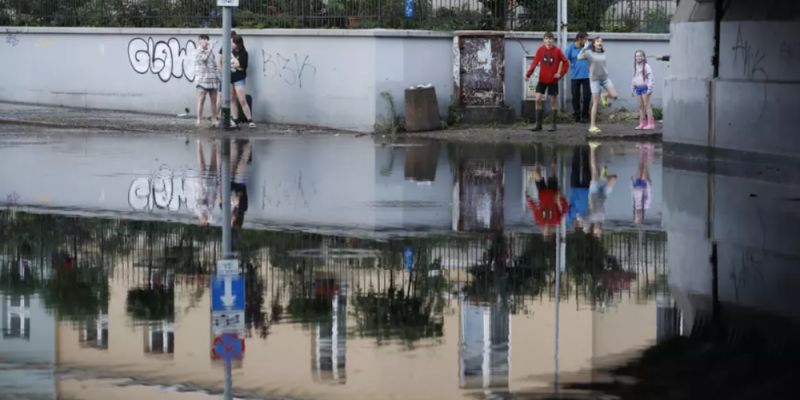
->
<box><xmin>525</xmin><ymin>32</ymin><xmax>569</xmax><ymax>132</ymax></box>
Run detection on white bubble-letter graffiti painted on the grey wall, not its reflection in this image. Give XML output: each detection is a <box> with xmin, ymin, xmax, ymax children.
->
<box><xmin>128</xmin><ymin>37</ymin><xmax>197</xmax><ymax>82</ymax></box>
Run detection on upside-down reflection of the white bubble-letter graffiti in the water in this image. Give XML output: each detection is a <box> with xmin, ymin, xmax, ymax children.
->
<box><xmin>128</xmin><ymin>167</ymin><xmax>199</xmax><ymax>212</ymax></box>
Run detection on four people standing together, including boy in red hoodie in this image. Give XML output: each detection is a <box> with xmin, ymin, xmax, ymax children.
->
<box><xmin>525</xmin><ymin>32</ymin><xmax>655</xmax><ymax>133</ymax></box>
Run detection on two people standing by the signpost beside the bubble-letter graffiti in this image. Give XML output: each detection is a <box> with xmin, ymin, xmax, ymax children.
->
<box><xmin>194</xmin><ymin>32</ymin><xmax>256</xmax><ymax>128</ymax></box>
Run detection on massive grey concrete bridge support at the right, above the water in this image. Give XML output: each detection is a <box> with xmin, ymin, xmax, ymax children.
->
<box><xmin>664</xmin><ymin>0</ymin><xmax>800</xmax><ymax>155</ymax></box>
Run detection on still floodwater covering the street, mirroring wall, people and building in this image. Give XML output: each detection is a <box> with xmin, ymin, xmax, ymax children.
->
<box><xmin>0</xmin><ymin>135</ymin><xmax>800</xmax><ymax>399</ymax></box>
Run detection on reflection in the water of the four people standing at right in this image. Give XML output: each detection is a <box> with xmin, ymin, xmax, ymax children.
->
<box><xmin>525</xmin><ymin>142</ymin><xmax>654</xmax><ymax>238</ymax></box>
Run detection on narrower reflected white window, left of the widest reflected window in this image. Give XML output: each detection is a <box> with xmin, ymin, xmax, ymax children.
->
<box><xmin>311</xmin><ymin>292</ymin><xmax>347</xmax><ymax>384</ymax></box>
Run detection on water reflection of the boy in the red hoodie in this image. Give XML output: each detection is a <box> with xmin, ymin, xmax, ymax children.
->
<box><xmin>525</xmin><ymin>164</ymin><xmax>569</xmax><ymax>238</ymax></box>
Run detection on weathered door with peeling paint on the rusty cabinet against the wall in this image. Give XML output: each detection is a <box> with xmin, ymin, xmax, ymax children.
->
<box><xmin>458</xmin><ymin>34</ymin><xmax>505</xmax><ymax>107</ymax></box>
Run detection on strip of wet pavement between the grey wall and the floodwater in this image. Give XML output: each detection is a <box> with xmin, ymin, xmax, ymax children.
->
<box><xmin>0</xmin><ymin>102</ymin><xmax>662</xmax><ymax>145</ymax></box>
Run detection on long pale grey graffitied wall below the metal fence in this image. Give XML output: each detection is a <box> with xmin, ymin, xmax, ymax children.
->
<box><xmin>0</xmin><ymin>27</ymin><xmax>667</xmax><ymax>132</ymax></box>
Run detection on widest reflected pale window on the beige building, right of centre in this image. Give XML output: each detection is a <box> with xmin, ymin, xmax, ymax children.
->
<box><xmin>459</xmin><ymin>299</ymin><xmax>511</xmax><ymax>389</ymax></box>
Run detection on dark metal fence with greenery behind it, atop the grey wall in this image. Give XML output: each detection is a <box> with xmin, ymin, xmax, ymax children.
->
<box><xmin>0</xmin><ymin>0</ymin><xmax>677</xmax><ymax>33</ymax></box>
